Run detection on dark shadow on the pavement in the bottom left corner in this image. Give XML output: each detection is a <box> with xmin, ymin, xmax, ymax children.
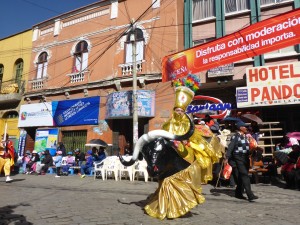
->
<box><xmin>0</xmin><ymin>204</ymin><xmax>33</xmax><ymax>225</ymax></box>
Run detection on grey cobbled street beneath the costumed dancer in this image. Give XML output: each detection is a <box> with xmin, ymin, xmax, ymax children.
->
<box><xmin>0</xmin><ymin>174</ymin><xmax>300</xmax><ymax>225</ymax></box>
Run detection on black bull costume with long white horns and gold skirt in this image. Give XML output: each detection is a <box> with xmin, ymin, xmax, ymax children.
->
<box><xmin>119</xmin><ymin>115</ymin><xmax>224</xmax><ymax>219</ymax></box>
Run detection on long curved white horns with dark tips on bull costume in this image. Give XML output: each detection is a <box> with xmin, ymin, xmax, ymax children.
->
<box><xmin>119</xmin><ymin>113</ymin><xmax>195</xmax><ymax>166</ymax></box>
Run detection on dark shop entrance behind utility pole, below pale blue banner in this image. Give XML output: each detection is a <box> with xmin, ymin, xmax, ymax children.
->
<box><xmin>113</xmin><ymin>118</ymin><xmax>149</xmax><ymax>155</ymax></box>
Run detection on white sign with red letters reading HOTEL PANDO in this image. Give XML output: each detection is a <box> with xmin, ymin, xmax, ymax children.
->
<box><xmin>236</xmin><ymin>62</ymin><xmax>300</xmax><ymax>108</ymax></box>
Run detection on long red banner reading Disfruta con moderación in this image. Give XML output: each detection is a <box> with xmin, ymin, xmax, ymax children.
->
<box><xmin>162</xmin><ymin>8</ymin><xmax>300</xmax><ymax>82</ymax></box>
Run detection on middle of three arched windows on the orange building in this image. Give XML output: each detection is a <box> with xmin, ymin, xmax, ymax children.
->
<box><xmin>72</xmin><ymin>41</ymin><xmax>89</xmax><ymax>73</ymax></box>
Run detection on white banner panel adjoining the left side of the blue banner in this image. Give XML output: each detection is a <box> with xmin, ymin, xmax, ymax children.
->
<box><xmin>18</xmin><ymin>102</ymin><xmax>53</xmax><ymax>127</ymax></box>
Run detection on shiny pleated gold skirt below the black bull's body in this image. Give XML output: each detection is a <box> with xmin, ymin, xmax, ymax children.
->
<box><xmin>144</xmin><ymin>161</ymin><xmax>205</xmax><ymax>220</ymax></box>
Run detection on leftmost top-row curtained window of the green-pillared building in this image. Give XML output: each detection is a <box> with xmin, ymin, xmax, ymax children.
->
<box><xmin>193</xmin><ymin>0</ymin><xmax>215</xmax><ymax>21</ymax></box>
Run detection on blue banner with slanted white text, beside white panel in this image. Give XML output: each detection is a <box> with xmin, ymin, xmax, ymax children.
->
<box><xmin>52</xmin><ymin>96</ymin><xmax>100</xmax><ymax>127</ymax></box>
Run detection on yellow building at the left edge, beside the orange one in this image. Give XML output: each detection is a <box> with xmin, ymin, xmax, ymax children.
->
<box><xmin>0</xmin><ymin>29</ymin><xmax>32</xmax><ymax>149</ymax></box>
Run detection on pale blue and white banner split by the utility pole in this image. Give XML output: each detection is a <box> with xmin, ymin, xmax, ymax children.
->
<box><xmin>106</xmin><ymin>90</ymin><xmax>155</xmax><ymax>119</ymax></box>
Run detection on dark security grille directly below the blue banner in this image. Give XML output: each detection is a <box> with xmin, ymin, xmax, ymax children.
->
<box><xmin>62</xmin><ymin>130</ymin><xmax>87</xmax><ymax>151</ymax></box>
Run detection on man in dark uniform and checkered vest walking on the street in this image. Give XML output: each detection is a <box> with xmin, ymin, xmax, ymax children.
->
<box><xmin>224</xmin><ymin>121</ymin><xmax>258</xmax><ymax>201</ymax></box>
